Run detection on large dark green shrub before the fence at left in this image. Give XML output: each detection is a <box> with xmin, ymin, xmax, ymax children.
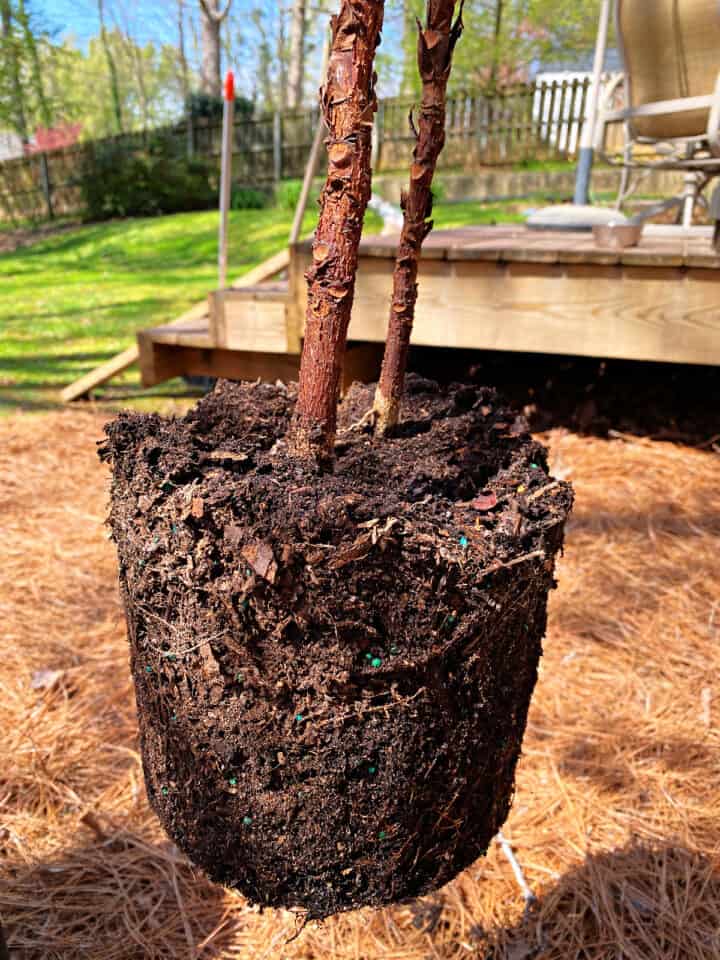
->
<box><xmin>80</xmin><ymin>136</ymin><xmax>217</xmax><ymax>220</ymax></box>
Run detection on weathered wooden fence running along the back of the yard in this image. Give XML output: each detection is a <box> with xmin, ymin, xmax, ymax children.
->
<box><xmin>0</xmin><ymin>79</ymin><xmax>589</xmax><ymax>219</ymax></box>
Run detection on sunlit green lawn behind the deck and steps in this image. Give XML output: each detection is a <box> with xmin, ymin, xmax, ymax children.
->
<box><xmin>0</xmin><ymin>201</ymin><xmax>530</xmax><ymax>413</ymax></box>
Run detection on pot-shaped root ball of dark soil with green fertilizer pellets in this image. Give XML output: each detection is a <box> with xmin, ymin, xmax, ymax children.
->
<box><xmin>101</xmin><ymin>377</ymin><xmax>572</xmax><ymax>917</ymax></box>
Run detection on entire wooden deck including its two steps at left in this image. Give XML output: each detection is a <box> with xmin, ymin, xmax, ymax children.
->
<box><xmin>138</xmin><ymin>226</ymin><xmax>720</xmax><ymax>385</ymax></box>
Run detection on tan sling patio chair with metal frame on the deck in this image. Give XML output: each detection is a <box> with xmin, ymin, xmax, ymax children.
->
<box><xmin>595</xmin><ymin>0</ymin><xmax>720</xmax><ymax>227</ymax></box>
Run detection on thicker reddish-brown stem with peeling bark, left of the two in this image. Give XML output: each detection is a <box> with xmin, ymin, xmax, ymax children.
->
<box><xmin>290</xmin><ymin>0</ymin><xmax>384</xmax><ymax>460</ymax></box>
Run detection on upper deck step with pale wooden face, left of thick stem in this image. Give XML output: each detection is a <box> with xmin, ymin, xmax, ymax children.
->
<box><xmin>209</xmin><ymin>282</ymin><xmax>297</xmax><ymax>353</ymax></box>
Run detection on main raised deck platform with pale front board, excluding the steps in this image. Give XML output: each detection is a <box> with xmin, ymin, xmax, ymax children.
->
<box><xmin>289</xmin><ymin>224</ymin><xmax>720</xmax><ymax>364</ymax></box>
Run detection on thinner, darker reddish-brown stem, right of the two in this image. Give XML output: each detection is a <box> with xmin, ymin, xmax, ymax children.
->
<box><xmin>374</xmin><ymin>0</ymin><xmax>462</xmax><ymax>435</ymax></box>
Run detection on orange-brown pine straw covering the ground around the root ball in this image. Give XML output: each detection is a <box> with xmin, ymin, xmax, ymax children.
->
<box><xmin>0</xmin><ymin>411</ymin><xmax>720</xmax><ymax>960</ymax></box>
